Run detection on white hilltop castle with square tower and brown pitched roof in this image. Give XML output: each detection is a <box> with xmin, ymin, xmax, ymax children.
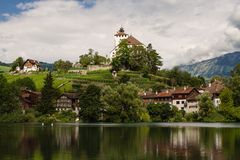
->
<box><xmin>110</xmin><ymin>27</ymin><xmax>144</xmax><ymax>59</ymax></box>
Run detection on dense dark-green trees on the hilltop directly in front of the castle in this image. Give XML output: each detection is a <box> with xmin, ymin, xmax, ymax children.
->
<box><xmin>112</xmin><ymin>40</ymin><xmax>162</xmax><ymax>74</ymax></box>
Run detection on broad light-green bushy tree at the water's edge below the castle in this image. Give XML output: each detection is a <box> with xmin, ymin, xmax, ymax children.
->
<box><xmin>101</xmin><ymin>83</ymin><xmax>150</xmax><ymax>122</ymax></box>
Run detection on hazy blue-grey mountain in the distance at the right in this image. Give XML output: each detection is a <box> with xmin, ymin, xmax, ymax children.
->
<box><xmin>179</xmin><ymin>51</ymin><xmax>240</xmax><ymax>78</ymax></box>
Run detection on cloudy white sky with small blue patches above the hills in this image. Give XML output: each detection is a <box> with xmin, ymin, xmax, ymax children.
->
<box><xmin>0</xmin><ymin>0</ymin><xmax>240</xmax><ymax>68</ymax></box>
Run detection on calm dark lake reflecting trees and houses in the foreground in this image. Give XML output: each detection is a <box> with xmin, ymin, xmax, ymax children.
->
<box><xmin>0</xmin><ymin>123</ymin><xmax>240</xmax><ymax>160</ymax></box>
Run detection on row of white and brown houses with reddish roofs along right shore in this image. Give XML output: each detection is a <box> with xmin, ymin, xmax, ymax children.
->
<box><xmin>141</xmin><ymin>80</ymin><xmax>224</xmax><ymax>113</ymax></box>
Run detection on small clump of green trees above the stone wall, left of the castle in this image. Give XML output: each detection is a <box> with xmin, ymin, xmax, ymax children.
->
<box><xmin>79</xmin><ymin>49</ymin><xmax>109</xmax><ymax>67</ymax></box>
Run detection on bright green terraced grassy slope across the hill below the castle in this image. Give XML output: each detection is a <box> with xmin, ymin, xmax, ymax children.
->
<box><xmin>5</xmin><ymin>70</ymin><xmax>168</xmax><ymax>91</ymax></box>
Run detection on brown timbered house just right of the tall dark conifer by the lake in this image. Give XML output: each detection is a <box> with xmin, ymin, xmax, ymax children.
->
<box><xmin>56</xmin><ymin>93</ymin><xmax>80</xmax><ymax>115</ymax></box>
